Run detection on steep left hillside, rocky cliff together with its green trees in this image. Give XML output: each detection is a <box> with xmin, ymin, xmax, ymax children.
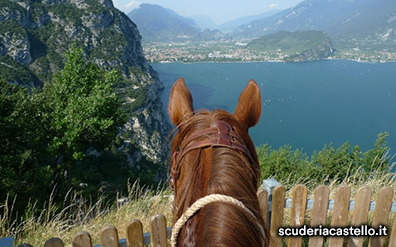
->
<box><xmin>0</xmin><ymin>0</ymin><xmax>169</xmax><ymax>214</ymax></box>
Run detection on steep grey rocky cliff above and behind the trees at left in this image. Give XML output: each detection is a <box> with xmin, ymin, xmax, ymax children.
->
<box><xmin>0</xmin><ymin>0</ymin><xmax>170</xmax><ymax>167</ymax></box>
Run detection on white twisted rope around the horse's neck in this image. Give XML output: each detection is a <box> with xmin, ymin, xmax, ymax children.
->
<box><xmin>171</xmin><ymin>194</ymin><xmax>264</xmax><ymax>247</ymax></box>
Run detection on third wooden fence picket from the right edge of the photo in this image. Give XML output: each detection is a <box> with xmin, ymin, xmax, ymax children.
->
<box><xmin>329</xmin><ymin>186</ymin><xmax>351</xmax><ymax>247</ymax></box>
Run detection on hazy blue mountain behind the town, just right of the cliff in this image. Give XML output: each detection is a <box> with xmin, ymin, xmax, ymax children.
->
<box><xmin>128</xmin><ymin>4</ymin><xmax>226</xmax><ymax>42</ymax></box>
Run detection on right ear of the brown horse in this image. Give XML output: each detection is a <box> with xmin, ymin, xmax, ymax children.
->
<box><xmin>233</xmin><ymin>80</ymin><xmax>261</xmax><ymax>129</ymax></box>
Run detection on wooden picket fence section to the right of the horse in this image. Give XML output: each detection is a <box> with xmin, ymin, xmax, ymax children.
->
<box><xmin>259</xmin><ymin>184</ymin><xmax>396</xmax><ymax>247</ymax></box>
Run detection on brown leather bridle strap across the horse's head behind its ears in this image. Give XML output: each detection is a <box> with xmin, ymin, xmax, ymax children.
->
<box><xmin>170</xmin><ymin>120</ymin><xmax>258</xmax><ymax>190</ymax></box>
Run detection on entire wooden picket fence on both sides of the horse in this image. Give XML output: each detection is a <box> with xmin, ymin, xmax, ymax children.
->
<box><xmin>5</xmin><ymin>183</ymin><xmax>396</xmax><ymax>247</ymax></box>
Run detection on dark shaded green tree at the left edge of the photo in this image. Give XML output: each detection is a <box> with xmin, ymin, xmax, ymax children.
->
<box><xmin>0</xmin><ymin>80</ymin><xmax>49</xmax><ymax>208</ymax></box>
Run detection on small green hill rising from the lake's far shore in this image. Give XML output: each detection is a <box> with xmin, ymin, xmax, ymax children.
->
<box><xmin>246</xmin><ymin>31</ymin><xmax>334</xmax><ymax>62</ymax></box>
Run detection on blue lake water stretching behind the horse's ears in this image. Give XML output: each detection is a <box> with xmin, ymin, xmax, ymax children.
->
<box><xmin>152</xmin><ymin>60</ymin><xmax>396</xmax><ymax>154</ymax></box>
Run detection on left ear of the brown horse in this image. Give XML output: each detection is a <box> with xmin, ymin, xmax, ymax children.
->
<box><xmin>168</xmin><ymin>78</ymin><xmax>194</xmax><ymax>126</ymax></box>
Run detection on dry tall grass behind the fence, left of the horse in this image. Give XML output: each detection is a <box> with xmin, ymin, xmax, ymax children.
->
<box><xmin>1</xmin><ymin>180</ymin><xmax>172</xmax><ymax>246</ymax></box>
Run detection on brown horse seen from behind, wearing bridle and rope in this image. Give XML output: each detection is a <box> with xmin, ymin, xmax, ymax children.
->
<box><xmin>168</xmin><ymin>78</ymin><xmax>269</xmax><ymax>247</ymax></box>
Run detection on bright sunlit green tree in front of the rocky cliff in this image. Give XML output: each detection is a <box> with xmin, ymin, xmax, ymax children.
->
<box><xmin>42</xmin><ymin>46</ymin><xmax>122</xmax><ymax>197</ymax></box>
